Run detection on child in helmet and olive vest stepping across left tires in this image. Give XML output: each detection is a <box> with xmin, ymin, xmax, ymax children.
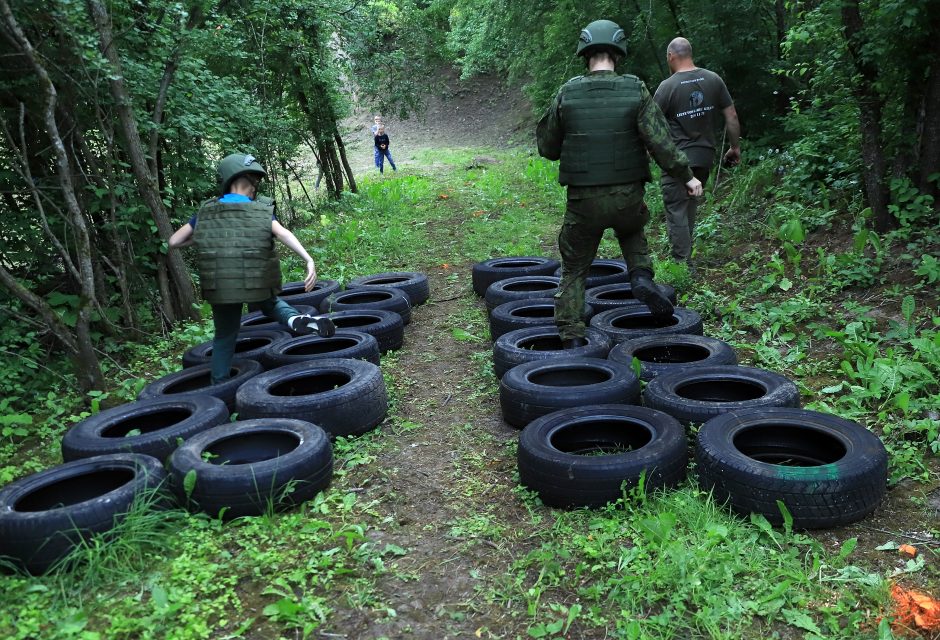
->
<box><xmin>169</xmin><ymin>153</ymin><xmax>336</xmax><ymax>383</ymax></box>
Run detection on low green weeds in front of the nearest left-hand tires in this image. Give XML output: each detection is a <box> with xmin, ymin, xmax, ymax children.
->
<box><xmin>0</xmin><ymin>492</ymin><xmax>386</xmax><ymax>639</ymax></box>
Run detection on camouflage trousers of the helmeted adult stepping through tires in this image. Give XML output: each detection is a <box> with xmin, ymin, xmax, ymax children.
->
<box><xmin>555</xmin><ymin>182</ymin><xmax>653</xmax><ymax>340</ymax></box>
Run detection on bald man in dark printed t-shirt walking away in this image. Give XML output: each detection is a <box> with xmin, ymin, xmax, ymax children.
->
<box><xmin>653</xmin><ymin>38</ymin><xmax>741</xmax><ymax>262</ymax></box>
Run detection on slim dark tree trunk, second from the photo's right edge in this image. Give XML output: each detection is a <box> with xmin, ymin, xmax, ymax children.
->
<box><xmin>842</xmin><ymin>0</ymin><xmax>896</xmax><ymax>233</ymax></box>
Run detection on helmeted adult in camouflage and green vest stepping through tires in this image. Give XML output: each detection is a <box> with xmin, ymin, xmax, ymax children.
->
<box><xmin>536</xmin><ymin>20</ymin><xmax>702</xmax><ymax>348</ymax></box>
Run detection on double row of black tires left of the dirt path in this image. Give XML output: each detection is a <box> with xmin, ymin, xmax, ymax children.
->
<box><xmin>0</xmin><ymin>273</ymin><xmax>429</xmax><ymax>574</ymax></box>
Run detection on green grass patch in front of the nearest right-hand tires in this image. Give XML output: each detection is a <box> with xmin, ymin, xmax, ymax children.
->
<box><xmin>500</xmin><ymin>486</ymin><xmax>887</xmax><ymax>639</ymax></box>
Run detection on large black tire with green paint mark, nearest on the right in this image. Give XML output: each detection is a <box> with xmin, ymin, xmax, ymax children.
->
<box><xmin>695</xmin><ymin>408</ymin><xmax>888</xmax><ymax>529</ymax></box>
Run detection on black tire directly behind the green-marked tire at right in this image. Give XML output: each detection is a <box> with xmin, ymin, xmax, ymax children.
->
<box><xmin>643</xmin><ymin>365</ymin><xmax>800</xmax><ymax>424</ymax></box>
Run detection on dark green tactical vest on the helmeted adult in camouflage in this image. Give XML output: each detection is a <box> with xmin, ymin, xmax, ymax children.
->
<box><xmin>558</xmin><ymin>74</ymin><xmax>650</xmax><ymax>187</ymax></box>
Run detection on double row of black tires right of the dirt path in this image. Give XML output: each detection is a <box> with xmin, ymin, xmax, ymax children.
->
<box><xmin>473</xmin><ymin>256</ymin><xmax>887</xmax><ymax>528</ymax></box>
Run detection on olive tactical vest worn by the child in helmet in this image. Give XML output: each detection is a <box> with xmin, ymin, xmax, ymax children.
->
<box><xmin>193</xmin><ymin>198</ymin><xmax>281</xmax><ymax>304</ymax></box>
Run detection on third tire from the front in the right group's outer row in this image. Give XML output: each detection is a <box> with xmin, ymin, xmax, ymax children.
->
<box><xmin>607</xmin><ymin>333</ymin><xmax>738</xmax><ymax>382</ymax></box>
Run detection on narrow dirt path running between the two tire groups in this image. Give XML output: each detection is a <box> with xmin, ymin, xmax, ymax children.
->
<box><xmin>324</xmin><ymin>225</ymin><xmax>525</xmax><ymax>640</ymax></box>
